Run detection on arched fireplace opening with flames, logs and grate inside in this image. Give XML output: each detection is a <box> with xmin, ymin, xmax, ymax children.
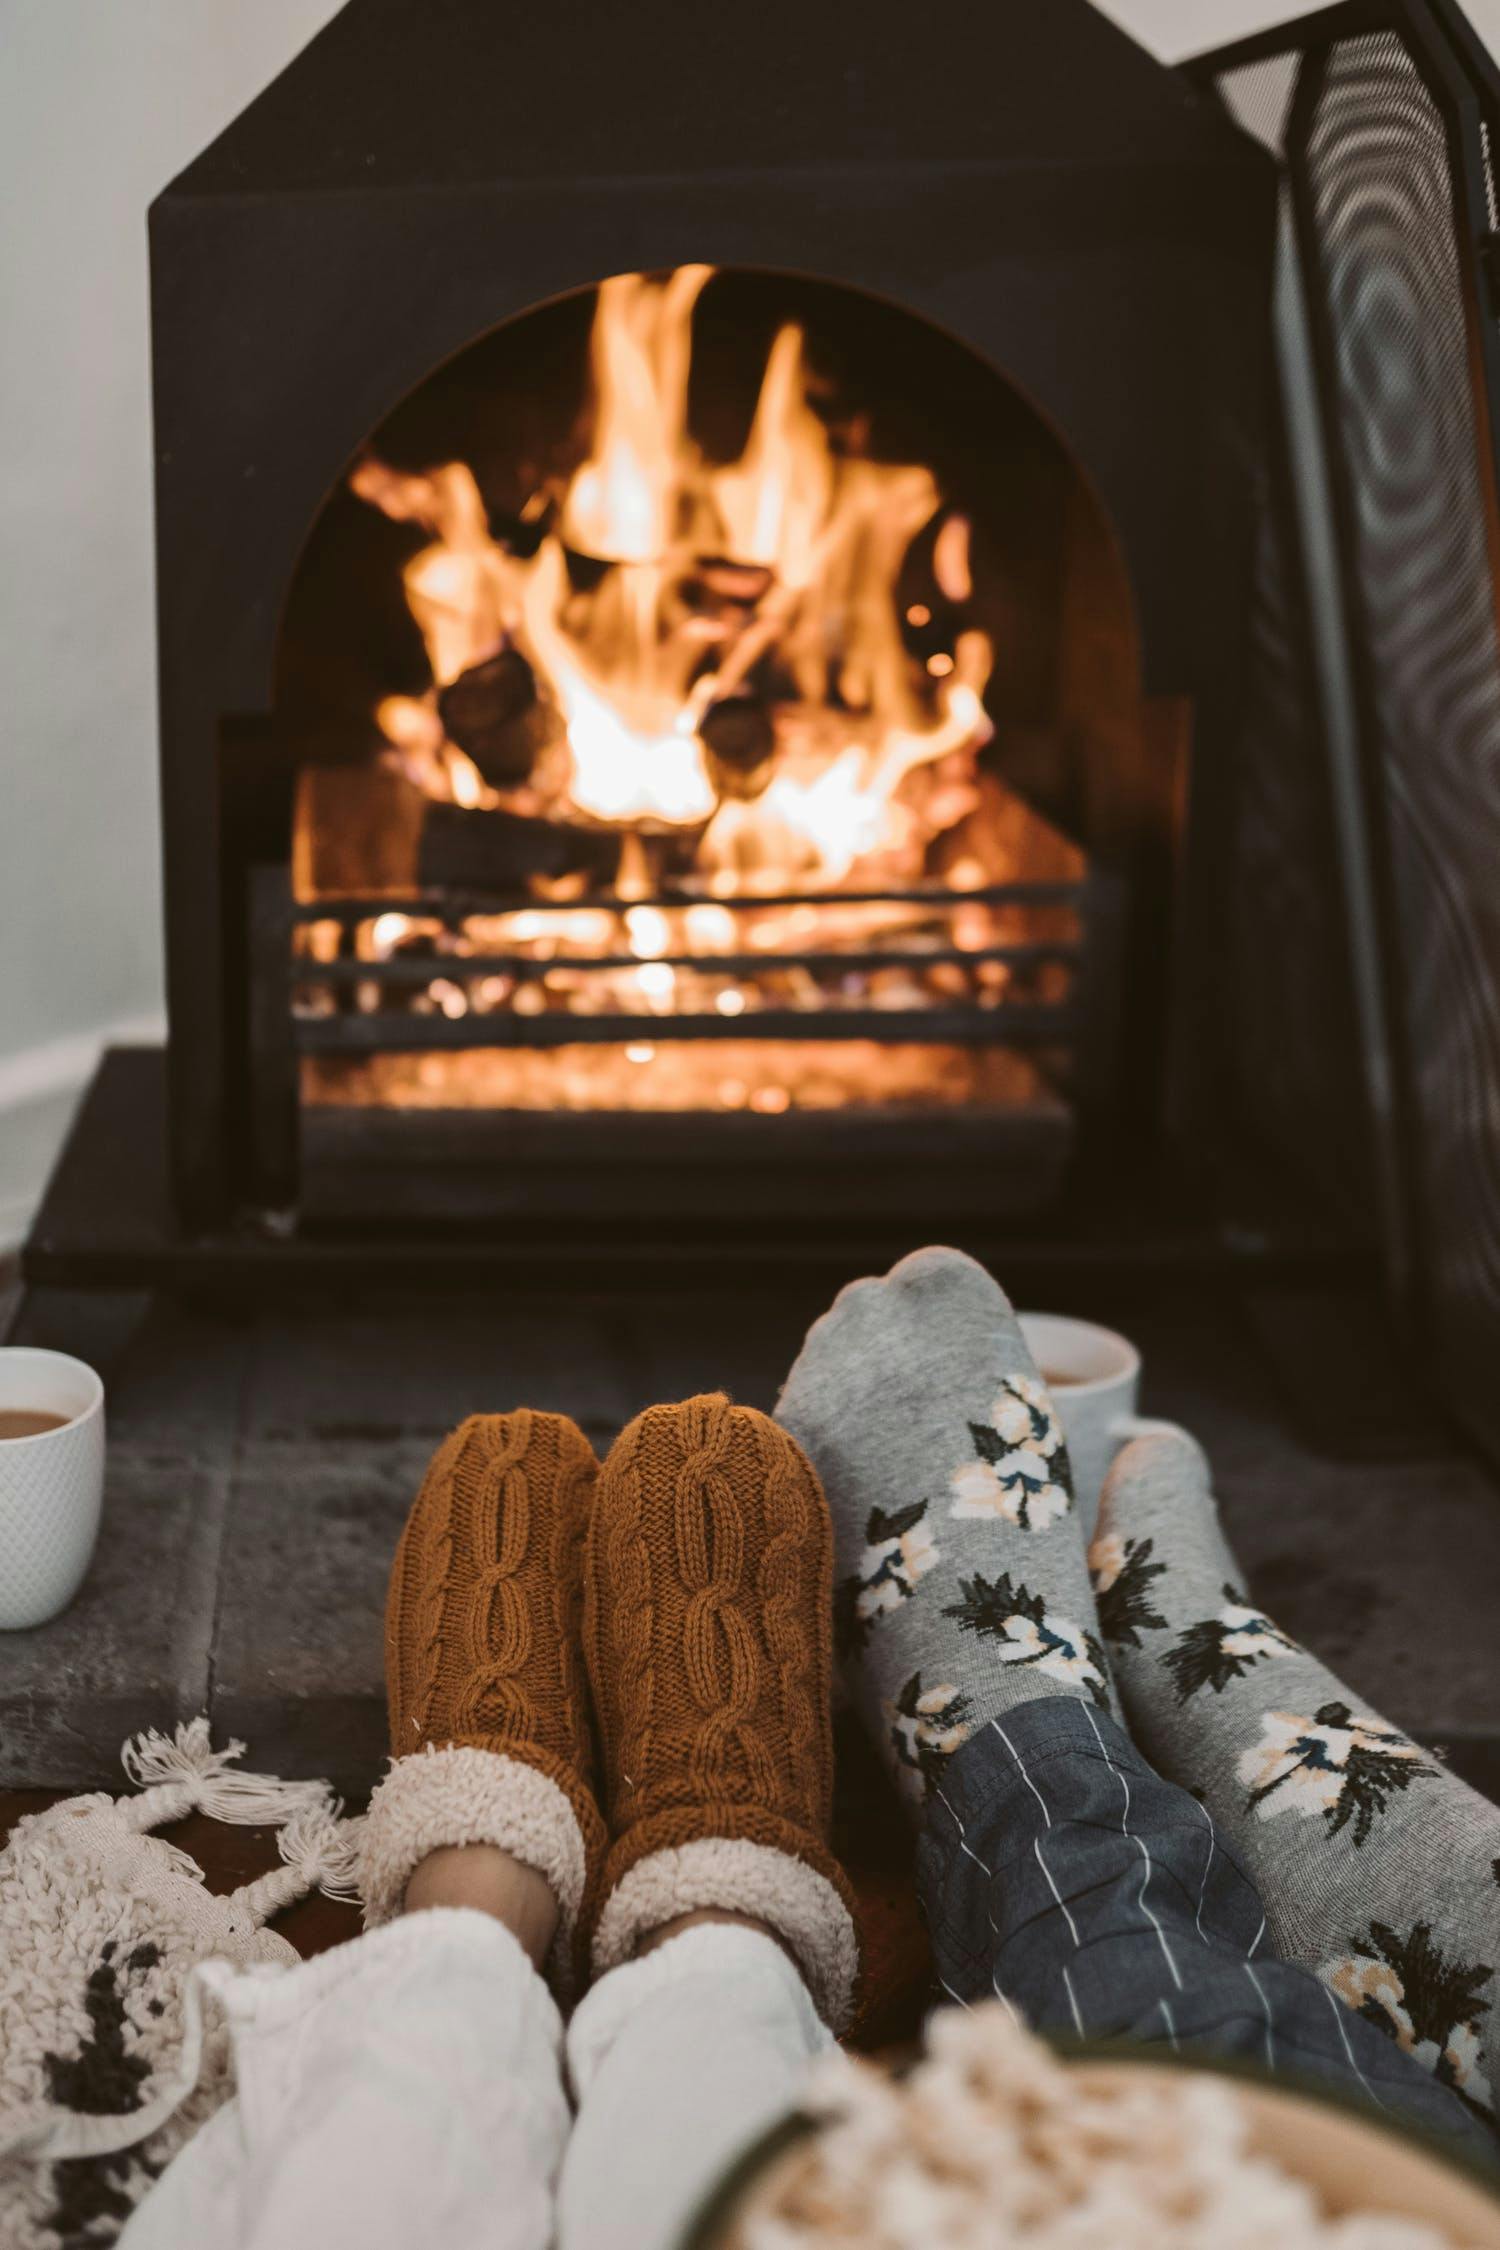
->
<box><xmin>264</xmin><ymin>268</ymin><xmax>1181</xmax><ymax>1215</ymax></box>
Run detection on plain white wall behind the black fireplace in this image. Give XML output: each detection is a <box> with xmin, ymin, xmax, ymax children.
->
<box><xmin>0</xmin><ymin>0</ymin><xmax>1500</xmax><ymax>1249</ymax></box>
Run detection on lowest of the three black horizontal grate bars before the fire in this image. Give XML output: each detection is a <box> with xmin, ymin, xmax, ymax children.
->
<box><xmin>292</xmin><ymin>1001</ymin><xmax>1079</xmax><ymax>1055</ymax></box>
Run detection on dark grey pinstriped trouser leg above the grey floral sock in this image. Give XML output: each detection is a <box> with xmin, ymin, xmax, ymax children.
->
<box><xmin>918</xmin><ymin>1697</ymin><xmax>1498</xmax><ymax>2165</ymax></box>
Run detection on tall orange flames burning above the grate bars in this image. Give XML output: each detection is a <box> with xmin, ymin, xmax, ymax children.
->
<box><xmin>351</xmin><ymin>266</ymin><xmax>992</xmax><ymax>893</ymax></box>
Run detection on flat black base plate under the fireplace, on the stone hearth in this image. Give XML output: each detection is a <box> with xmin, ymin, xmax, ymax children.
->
<box><xmin>22</xmin><ymin>1049</ymin><xmax>1372</xmax><ymax>1303</ymax></box>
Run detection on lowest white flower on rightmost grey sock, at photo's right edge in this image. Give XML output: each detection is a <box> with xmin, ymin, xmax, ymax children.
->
<box><xmin>1320</xmin><ymin>1922</ymin><xmax>1496</xmax><ymax>2111</ymax></box>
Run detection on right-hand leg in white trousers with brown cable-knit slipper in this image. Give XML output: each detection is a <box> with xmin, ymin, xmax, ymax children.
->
<box><xmin>558</xmin><ymin>1397</ymin><xmax>857</xmax><ymax>2250</ymax></box>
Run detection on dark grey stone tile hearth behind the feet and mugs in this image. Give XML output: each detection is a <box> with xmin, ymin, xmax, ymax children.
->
<box><xmin>0</xmin><ymin>1276</ymin><xmax>1500</xmax><ymax>1791</ymax></box>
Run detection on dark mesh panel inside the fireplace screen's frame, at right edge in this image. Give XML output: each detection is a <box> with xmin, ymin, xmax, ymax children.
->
<box><xmin>1293</xmin><ymin>32</ymin><xmax>1500</xmax><ymax>1431</ymax></box>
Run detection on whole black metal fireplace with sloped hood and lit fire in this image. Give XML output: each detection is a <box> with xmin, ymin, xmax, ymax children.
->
<box><xmin>111</xmin><ymin>0</ymin><xmax>1275</xmax><ymax>1240</ymax></box>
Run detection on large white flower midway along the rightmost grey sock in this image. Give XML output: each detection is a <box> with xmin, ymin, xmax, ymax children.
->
<box><xmin>1237</xmin><ymin>1703</ymin><xmax>1433</xmax><ymax>1847</ymax></box>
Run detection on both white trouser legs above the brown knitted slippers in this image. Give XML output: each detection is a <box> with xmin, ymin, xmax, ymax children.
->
<box><xmin>119</xmin><ymin>1910</ymin><xmax>832</xmax><ymax>2250</ymax></box>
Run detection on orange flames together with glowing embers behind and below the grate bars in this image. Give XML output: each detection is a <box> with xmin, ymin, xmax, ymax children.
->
<box><xmin>297</xmin><ymin>266</ymin><xmax>1082</xmax><ymax>1116</ymax></box>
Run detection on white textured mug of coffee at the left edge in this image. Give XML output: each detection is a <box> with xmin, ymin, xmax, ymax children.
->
<box><xmin>0</xmin><ymin>1346</ymin><xmax>103</xmax><ymax>1631</ymax></box>
